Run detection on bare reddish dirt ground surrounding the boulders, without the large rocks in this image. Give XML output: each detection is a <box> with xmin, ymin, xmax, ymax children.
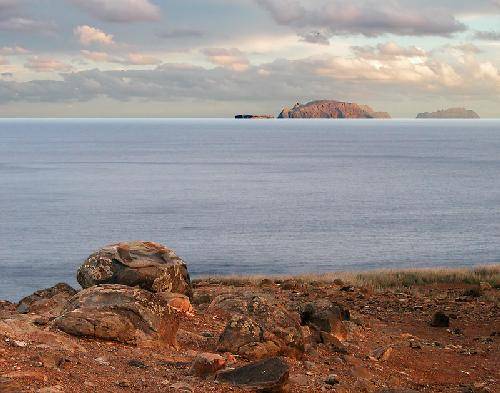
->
<box><xmin>0</xmin><ymin>280</ymin><xmax>500</xmax><ymax>393</ymax></box>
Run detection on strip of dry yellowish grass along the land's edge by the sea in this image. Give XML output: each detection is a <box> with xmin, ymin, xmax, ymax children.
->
<box><xmin>195</xmin><ymin>264</ymin><xmax>500</xmax><ymax>289</ymax></box>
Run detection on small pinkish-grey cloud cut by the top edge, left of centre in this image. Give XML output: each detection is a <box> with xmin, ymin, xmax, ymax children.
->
<box><xmin>69</xmin><ymin>0</ymin><xmax>161</xmax><ymax>23</ymax></box>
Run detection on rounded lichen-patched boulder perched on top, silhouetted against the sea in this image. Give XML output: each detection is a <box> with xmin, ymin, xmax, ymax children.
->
<box><xmin>77</xmin><ymin>241</ymin><xmax>191</xmax><ymax>296</ymax></box>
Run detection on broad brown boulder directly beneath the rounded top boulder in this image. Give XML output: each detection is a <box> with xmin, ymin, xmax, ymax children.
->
<box><xmin>55</xmin><ymin>284</ymin><xmax>178</xmax><ymax>346</ymax></box>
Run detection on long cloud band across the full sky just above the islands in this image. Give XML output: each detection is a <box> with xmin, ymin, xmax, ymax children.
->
<box><xmin>0</xmin><ymin>43</ymin><xmax>500</xmax><ymax>109</ymax></box>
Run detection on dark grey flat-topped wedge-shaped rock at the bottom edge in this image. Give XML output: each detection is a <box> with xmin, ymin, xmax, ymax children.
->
<box><xmin>217</xmin><ymin>357</ymin><xmax>289</xmax><ymax>391</ymax></box>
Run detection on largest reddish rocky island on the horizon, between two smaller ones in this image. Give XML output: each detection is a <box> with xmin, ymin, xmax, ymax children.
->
<box><xmin>278</xmin><ymin>100</ymin><xmax>391</xmax><ymax>119</ymax></box>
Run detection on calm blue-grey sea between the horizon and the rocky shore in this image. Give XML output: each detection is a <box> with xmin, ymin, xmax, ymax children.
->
<box><xmin>0</xmin><ymin>120</ymin><xmax>500</xmax><ymax>299</ymax></box>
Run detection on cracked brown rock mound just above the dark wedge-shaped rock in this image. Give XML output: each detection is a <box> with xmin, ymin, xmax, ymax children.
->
<box><xmin>207</xmin><ymin>292</ymin><xmax>304</xmax><ymax>359</ymax></box>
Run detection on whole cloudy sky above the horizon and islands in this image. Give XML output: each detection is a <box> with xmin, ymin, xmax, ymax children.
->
<box><xmin>0</xmin><ymin>0</ymin><xmax>500</xmax><ymax>118</ymax></box>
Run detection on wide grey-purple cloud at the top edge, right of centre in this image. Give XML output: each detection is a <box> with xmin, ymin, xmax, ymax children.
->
<box><xmin>255</xmin><ymin>0</ymin><xmax>466</xmax><ymax>38</ymax></box>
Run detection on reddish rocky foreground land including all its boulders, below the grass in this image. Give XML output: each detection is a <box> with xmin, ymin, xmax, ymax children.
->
<box><xmin>0</xmin><ymin>242</ymin><xmax>500</xmax><ymax>393</ymax></box>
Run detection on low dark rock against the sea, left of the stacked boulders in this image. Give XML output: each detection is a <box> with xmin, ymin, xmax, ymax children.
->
<box><xmin>16</xmin><ymin>283</ymin><xmax>76</xmax><ymax>318</ymax></box>
